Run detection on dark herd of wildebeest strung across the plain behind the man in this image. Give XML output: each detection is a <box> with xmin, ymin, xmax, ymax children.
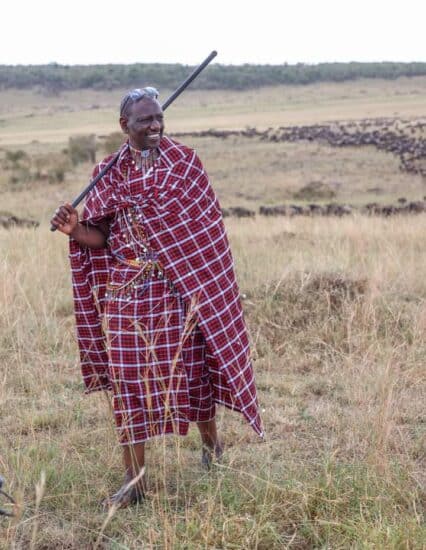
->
<box><xmin>0</xmin><ymin>118</ymin><xmax>426</xmax><ymax>227</ymax></box>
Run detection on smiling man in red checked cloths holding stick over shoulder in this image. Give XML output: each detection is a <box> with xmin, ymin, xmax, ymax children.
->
<box><xmin>51</xmin><ymin>88</ymin><xmax>263</xmax><ymax>506</ymax></box>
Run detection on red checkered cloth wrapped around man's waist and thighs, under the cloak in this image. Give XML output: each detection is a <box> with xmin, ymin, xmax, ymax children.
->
<box><xmin>105</xmin><ymin>278</ymin><xmax>215</xmax><ymax>444</ymax></box>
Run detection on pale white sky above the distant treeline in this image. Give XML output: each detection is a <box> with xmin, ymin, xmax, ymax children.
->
<box><xmin>0</xmin><ymin>0</ymin><xmax>426</xmax><ymax>65</ymax></box>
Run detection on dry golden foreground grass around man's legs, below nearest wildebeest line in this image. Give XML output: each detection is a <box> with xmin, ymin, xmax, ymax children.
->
<box><xmin>0</xmin><ymin>217</ymin><xmax>426</xmax><ymax>548</ymax></box>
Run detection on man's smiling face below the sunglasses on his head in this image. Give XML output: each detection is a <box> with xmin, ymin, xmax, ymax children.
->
<box><xmin>120</xmin><ymin>98</ymin><xmax>164</xmax><ymax>149</ymax></box>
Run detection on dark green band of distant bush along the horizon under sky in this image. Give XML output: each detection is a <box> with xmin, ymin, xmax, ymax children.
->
<box><xmin>0</xmin><ymin>62</ymin><xmax>426</xmax><ymax>94</ymax></box>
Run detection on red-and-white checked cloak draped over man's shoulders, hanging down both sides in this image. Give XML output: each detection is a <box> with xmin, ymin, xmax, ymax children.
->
<box><xmin>70</xmin><ymin>136</ymin><xmax>263</xmax><ymax>437</ymax></box>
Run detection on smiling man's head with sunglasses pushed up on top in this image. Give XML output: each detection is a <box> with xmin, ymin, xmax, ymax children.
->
<box><xmin>120</xmin><ymin>87</ymin><xmax>164</xmax><ymax>153</ymax></box>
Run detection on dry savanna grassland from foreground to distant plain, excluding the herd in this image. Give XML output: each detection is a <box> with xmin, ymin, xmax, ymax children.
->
<box><xmin>0</xmin><ymin>77</ymin><xmax>426</xmax><ymax>550</ymax></box>
